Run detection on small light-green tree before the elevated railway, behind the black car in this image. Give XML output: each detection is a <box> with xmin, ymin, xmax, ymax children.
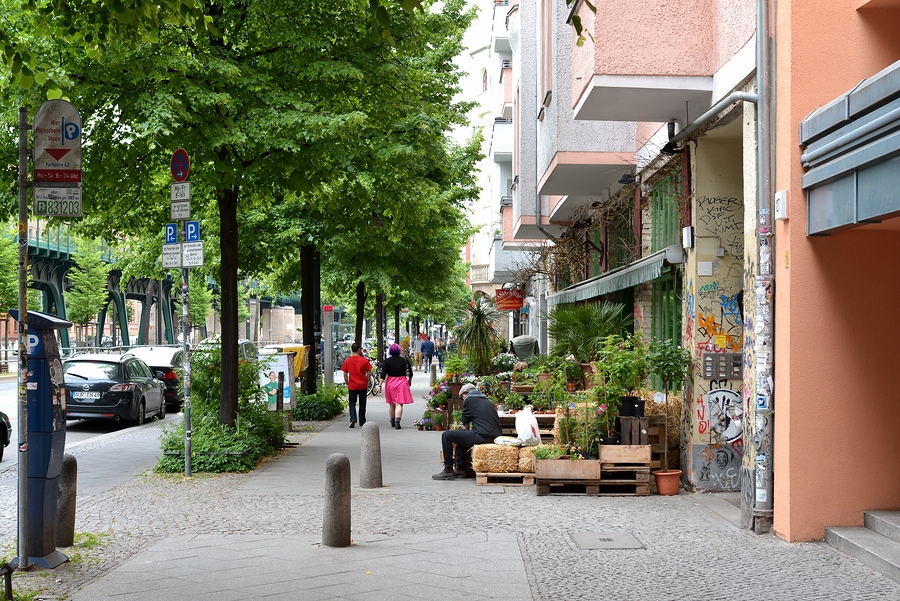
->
<box><xmin>65</xmin><ymin>238</ymin><xmax>112</xmax><ymax>340</ymax></box>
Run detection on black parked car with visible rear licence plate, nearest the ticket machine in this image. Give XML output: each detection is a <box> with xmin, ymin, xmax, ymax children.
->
<box><xmin>63</xmin><ymin>354</ymin><xmax>166</xmax><ymax>425</ymax></box>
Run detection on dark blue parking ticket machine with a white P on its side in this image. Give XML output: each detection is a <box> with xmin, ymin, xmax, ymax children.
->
<box><xmin>9</xmin><ymin>309</ymin><xmax>72</xmax><ymax>568</ymax></box>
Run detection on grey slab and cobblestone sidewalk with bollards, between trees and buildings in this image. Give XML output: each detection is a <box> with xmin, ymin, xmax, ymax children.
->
<box><xmin>0</xmin><ymin>372</ymin><xmax>900</xmax><ymax>601</ymax></box>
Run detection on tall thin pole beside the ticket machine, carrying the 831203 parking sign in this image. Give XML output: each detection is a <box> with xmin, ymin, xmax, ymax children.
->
<box><xmin>16</xmin><ymin>107</ymin><xmax>30</xmax><ymax>569</ymax></box>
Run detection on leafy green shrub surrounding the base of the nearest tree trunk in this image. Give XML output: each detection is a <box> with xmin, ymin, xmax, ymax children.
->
<box><xmin>155</xmin><ymin>346</ymin><xmax>284</xmax><ymax>473</ymax></box>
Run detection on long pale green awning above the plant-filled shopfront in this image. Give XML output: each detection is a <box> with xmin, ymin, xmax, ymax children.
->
<box><xmin>547</xmin><ymin>246</ymin><xmax>684</xmax><ymax>307</ymax></box>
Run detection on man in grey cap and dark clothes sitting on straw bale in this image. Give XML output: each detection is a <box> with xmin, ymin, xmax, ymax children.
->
<box><xmin>432</xmin><ymin>384</ymin><xmax>502</xmax><ymax>480</ymax></box>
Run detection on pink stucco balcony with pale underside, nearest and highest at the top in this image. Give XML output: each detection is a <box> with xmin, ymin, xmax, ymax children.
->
<box><xmin>572</xmin><ymin>0</ymin><xmax>756</xmax><ymax>125</ymax></box>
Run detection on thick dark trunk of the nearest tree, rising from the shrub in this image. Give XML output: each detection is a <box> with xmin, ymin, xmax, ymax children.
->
<box><xmin>218</xmin><ymin>186</ymin><xmax>239</xmax><ymax>426</ymax></box>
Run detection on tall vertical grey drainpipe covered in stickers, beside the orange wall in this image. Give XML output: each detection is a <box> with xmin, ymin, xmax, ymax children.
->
<box><xmin>748</xmin><ymin>0</ymin><xmax>775</xmax><ymax>534</ymax></box>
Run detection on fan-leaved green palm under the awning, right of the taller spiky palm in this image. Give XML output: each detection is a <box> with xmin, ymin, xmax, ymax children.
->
<box><xmin>546</xmin><ymin>302</ymin><xmax>632</xmax><ymax>363</ymax></box>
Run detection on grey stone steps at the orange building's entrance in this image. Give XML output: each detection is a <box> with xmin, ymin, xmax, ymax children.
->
<box><xmin>825</xmin><ymin>510</ymin><xmax>900</xmax><ymax>582</ymax></box>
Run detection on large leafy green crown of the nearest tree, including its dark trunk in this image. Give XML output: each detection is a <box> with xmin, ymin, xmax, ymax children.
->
<box><xmin>0</xmin><ymin>0</ymin><xmax>473</xmax><ymax>424</ymax></box>
